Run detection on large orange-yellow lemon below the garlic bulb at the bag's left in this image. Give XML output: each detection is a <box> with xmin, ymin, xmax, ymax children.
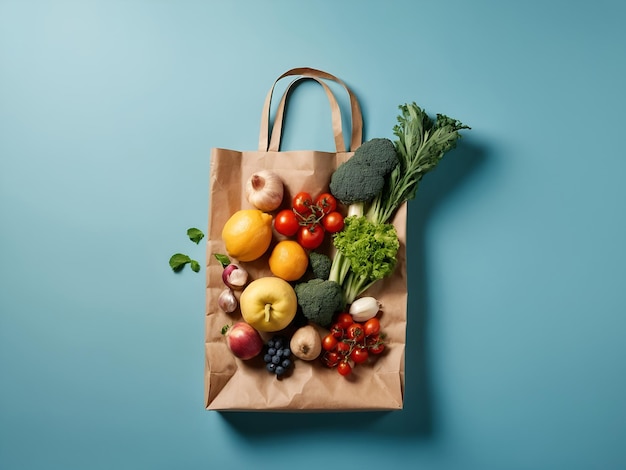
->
<box><xmin>222</xmin><ymin>209</ymin><xmax>272</xmax><ymax>261</ymax></box>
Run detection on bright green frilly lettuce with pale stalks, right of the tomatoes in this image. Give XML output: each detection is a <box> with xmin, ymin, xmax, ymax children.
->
<box><xmin>329</xmin><ymin>216</ymin><xmax>400</xmax><ymax>304</ymax></box>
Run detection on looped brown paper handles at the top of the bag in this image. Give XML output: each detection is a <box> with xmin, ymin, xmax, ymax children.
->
<box><xmin>259</xmin><ymin>67</ymin><xmax>363</xmax><ymax>151</ymax></box>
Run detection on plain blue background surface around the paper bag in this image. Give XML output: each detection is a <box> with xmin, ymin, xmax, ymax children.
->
<box><xmin>0</xmin><ymin>0</ymin><xmax>626</xmax><ymax>470</ymax></box>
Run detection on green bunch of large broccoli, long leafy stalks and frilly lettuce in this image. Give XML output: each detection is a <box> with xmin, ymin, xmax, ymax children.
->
<box><xmin>329</xmin><ymin>103</ymin><xmax>469</xmax><ymax>304</ymax></box>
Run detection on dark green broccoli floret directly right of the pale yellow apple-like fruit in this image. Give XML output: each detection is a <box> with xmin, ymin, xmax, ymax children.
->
<box><xmin>294</xmin><ymin>279</ymin><xmax>345</xmax><ymax>326</ymax></box>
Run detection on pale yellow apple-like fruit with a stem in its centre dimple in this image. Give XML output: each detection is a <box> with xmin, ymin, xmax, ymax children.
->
<box><xmin>239</xmin><ymin>277</ymin><xmax>298</xmax><ymax>332</ymax></box>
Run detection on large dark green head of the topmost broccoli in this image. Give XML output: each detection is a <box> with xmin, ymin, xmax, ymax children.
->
<box><xmin>330</xmin><ymin>138</ymin><xmax>399</xmax><ymax>206</ymax></box>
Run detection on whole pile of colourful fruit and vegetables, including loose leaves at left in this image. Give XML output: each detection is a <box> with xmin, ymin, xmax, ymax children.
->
<box><xmin>197</xmin><ymin>103</ymin><xmax>469</xmax><ymax>378</ymax></box>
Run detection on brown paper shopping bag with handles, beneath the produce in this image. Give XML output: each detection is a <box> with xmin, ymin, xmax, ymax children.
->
<box><xmin>205</xmin><ymin>68</ymin><xmax>407</xmax><ymax>411</ymax></box>
